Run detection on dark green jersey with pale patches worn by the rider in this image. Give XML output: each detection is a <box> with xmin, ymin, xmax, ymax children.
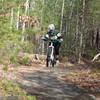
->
<box><xmin>45</xmin><ymin>31</ymin><xmax>63</xmax><ymax>43</ymax></box>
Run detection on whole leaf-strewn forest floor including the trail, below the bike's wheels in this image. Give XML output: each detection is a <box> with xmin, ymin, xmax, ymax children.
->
<box><xmin>0</xmin><ymin>52</ymin><xmax>100</xmax><ymax>100</ymax></box>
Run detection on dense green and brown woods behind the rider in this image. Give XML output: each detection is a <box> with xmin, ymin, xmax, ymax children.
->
<box><xmin>0</xmin><ymin>0</ymin><xmax>100</xmax><ymax>62</ymax></box>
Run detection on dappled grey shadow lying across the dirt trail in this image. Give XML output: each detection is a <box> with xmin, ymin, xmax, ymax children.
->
<box><xmin>18</xmin><ymin>71</ymin><xmax>95</xmax><ymax>100</ymax></box>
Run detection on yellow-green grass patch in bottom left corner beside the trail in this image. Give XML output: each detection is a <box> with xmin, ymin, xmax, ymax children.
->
<box><xmin>0</xmin><ymin>79</ymin><xmax>36</xmax><ymax>100</ymax></box>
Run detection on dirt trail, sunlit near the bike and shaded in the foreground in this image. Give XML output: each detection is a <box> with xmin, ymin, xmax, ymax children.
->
<box><xmin>15</xmin><ymin>64</ymin><xmax>100</xmax><ymax>100</ymax></box>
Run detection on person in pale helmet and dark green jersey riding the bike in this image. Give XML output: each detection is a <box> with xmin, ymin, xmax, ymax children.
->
<box><xmin>43</xmin><ymin>24</ymin><xmax>63</xmax><ymax>63</ymax></box>
